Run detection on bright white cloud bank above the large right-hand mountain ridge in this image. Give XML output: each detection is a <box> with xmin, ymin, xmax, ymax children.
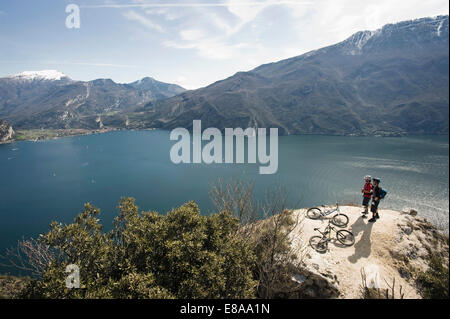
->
<box><xmin>117</xmin><ymin>0</ymin><xmax>449</xmax><ymax>87</ymax></box>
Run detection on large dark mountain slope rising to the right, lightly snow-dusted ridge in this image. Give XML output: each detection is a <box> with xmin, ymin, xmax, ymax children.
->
<box><xmin>134</xmin><ymin>16</ymin><xmax>449</xmax><ymax>135</ymax></box>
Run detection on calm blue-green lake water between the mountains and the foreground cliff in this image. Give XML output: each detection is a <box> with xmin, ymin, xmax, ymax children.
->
<box><xmin>0</xmin><ymin>131</ymin><xmax>449</xmax><ymax>274</ymax></box>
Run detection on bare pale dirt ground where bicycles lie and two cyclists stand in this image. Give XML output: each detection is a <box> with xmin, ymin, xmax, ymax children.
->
<box><xmin>296</xmin><ymin>206</ymin><xmax>420</xmax><ymax>298</ymax></box>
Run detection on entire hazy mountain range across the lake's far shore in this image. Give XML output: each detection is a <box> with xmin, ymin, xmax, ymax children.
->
<box><xmin>0</xmin><ymin>15</ymin><xmax>449</xmax><ymax>135</ymax></box>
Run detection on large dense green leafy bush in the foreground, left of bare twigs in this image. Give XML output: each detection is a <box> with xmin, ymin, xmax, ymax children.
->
<box><xmin>20</xmin><ymin>198</ymin><xmax>257</xmax><ymax>298</ymax></box>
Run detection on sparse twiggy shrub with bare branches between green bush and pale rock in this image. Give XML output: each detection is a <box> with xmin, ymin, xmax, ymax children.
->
<box><xmin>210</xmin><ymin>179</ymin><xmax>305</xmax><ymax>299</ymax></box>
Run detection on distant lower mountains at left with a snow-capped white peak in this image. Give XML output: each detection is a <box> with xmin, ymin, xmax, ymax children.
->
<box><xmin>0</xmin><ymin>70</ymin><xmax>184</xmax><ymax>128</ymax></box>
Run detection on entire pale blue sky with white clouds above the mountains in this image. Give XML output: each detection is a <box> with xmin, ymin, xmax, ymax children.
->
<box><xmin>0</xmin><ymin>0</ymin><xmax>449</xmax><ymax>89</ymax></box>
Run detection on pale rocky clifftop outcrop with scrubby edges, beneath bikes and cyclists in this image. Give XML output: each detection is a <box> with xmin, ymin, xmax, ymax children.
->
<box><xmin>292</xmin><ymin>206</ymin><xmax>449</xmax><ymax>299</ymax></box>
